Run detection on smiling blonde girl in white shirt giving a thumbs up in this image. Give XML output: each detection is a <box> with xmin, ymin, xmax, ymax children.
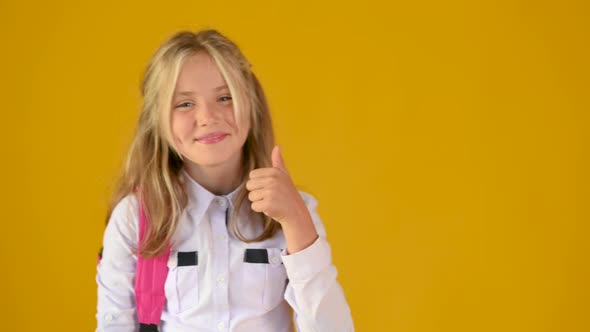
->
<box><xmin>96</xmin><ymin>30</ymin><xmax>354</xmax><ymax>332</ymax></box>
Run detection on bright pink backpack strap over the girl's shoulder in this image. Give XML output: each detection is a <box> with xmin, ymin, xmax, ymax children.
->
<box><xmin>135</xmin><ymin>195</ymin><xmax>170</xmax><ymax>332</ymax></box>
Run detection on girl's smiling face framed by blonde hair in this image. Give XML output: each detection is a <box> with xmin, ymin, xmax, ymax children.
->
<box><xmin>171</xmin><ymin>52</ymin><xmax>250</xmax><ymax>169</ymax></box>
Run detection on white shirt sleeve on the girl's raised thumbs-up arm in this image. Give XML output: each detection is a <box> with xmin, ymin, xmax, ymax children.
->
<box><xmin>282</xmin><ymin>192</ymin><xmax>354</xmax><ymax>332</ymax></box>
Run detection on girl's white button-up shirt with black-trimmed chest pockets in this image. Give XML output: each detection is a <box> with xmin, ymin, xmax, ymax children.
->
<box><xmin>96</xmin><ymin>170</ymin><xmax>354</xmax><ymax>332</ymax></box>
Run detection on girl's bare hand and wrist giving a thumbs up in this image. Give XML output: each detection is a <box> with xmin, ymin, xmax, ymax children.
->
<box><xmin>246</xmin><ymin>146</ymin><xmax>311</xmax><ymax>226</ymax></box>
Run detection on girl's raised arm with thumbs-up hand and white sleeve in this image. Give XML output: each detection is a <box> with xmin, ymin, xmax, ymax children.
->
<box><xmin>246</xmin><ymin>146</ymin><xmax>354</xmax><ymax>332</ymax></box>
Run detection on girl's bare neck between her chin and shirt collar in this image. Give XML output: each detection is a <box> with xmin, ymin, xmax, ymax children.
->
<box><xmin>183</xmin><ymin>160</ymin><xmax>242</xmax><ymax>195</ymax></box>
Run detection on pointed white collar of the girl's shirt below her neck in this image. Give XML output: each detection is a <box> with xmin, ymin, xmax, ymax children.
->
<box><xmin>181</xmin><ymin>168</ymin><xmax>242</xmax><ymax>224</ymax></box>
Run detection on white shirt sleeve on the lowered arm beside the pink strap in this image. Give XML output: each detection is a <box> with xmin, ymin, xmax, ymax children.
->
<box><xmin>96</xmin><ymin>195</ymin><xmax>139</xmax><ymax>332</ymax></box>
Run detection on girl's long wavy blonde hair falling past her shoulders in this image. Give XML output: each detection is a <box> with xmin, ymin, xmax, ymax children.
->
<box><xmin>107</xmin><ymin>30</ymin><xmax>280</xmax><ymax>258</ymax></box>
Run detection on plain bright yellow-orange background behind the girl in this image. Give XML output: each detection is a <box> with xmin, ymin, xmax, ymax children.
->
<box><xmin>0</xmin><ymin>0</ymin><xmax>590</xmax><ymax>332</ymax></box>
